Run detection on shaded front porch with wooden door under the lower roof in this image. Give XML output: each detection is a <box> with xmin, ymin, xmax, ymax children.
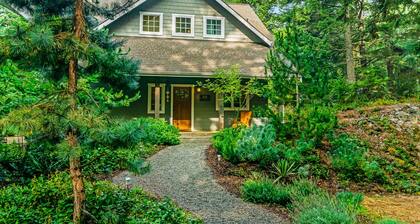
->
<box><xmin>113</xmin><ymin>76</ymin><xmax>266</xmax><ymax>132</ymax></box>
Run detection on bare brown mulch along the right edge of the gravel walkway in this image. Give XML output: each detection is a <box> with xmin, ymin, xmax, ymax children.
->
<box><xmin>206</xmin><ymin>146</ymin><xmax>290</xmax><ymax>221</ymax></box>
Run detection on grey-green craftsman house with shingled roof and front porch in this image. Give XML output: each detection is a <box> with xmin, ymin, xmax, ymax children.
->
<box><xmin>98</xmin><ymin>0</ymin><xmax>272</xmax><ymax>131</ymax></box>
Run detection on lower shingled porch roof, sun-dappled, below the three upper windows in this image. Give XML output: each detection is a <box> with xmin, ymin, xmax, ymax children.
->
<box><xmin>116</xmin><ymin>37</ymin><xmax>269</xmax><ymax>78</ymax></box>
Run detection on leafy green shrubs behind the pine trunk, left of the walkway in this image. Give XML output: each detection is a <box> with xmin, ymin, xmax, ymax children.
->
<box><xmin>0</xmin><ymin>118</ymin><xmax>179</xmax><ymax>183</ymax></box>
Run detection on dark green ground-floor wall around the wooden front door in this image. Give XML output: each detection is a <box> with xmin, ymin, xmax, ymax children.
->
<box><xmin>112</xmin><ymin>77</ymin><xmax>267</xmax><ymax>131</ymax></box>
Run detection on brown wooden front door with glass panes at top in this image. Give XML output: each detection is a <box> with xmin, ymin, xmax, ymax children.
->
<box><xmin>173</xmin><ymin>87</ymin><xmax>192</xmax><ymax>131</ymax></box>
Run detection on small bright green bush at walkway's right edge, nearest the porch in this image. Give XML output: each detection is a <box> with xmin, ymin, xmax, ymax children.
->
<box><xmin>212</xmin><ymin>126</ymin><xmax>245</xmax><ymax>163</ymax></box>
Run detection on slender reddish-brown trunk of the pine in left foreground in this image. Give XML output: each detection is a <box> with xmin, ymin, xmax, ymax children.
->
<box><xmin>67</xmin><ymin>0</ymin><xmax>85</xmax><ymax>224</ymax></box>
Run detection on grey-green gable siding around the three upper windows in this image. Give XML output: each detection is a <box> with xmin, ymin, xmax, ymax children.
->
<box><xmin>108</xmin><ymin>0</ymin><xmax>261</xmax><ymax>43</ymax></box>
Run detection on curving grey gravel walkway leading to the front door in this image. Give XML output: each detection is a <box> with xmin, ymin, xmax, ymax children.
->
<box><xmin>114</xmin><ymin>139</ymin><xmax>283</xmax><ymax>224</ymax></box>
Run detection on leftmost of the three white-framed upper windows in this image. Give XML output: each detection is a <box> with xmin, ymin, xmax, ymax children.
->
<box><xmin>140</xmin><ymin>12</ymin><xmax>163</xmax><ymax>35</ymax></box>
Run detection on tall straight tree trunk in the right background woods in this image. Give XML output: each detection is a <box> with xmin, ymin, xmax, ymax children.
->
<box><xmin>344</xmin><ymin>5</ymin><xmax>356</xmax><ymax>83</ymax></box>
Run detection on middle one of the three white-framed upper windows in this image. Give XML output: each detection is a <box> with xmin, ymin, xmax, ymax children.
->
<box><xmin>172</xmin><ymin>14</ymin><xmax>194</xmax><ymax>37</ymax></box>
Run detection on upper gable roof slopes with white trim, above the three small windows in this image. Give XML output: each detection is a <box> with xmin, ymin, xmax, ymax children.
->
<box><xmin>96</xmin><ymin>0</ymin><xmax>273</xmax><ymax>46</ymax></box>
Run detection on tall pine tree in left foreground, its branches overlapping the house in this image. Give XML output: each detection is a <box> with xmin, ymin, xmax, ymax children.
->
<box><xmin>0</xmin><ymin>0</ymin><xmax>138</xmax><ymax>223</ymax></box>
